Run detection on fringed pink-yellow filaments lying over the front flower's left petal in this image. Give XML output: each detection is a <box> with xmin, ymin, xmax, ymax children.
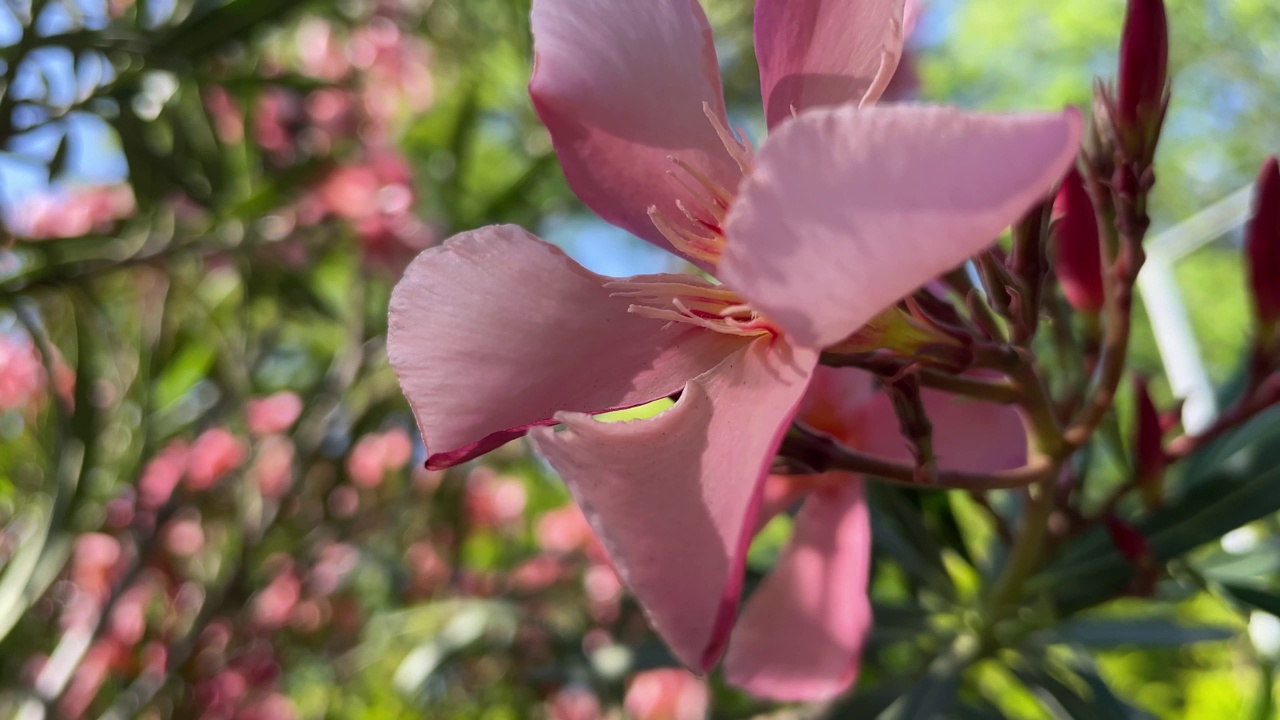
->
<box><xmin>604</xmin><ymin>275</ymin><xmax>777</xmax><ymax>337</ymax></box>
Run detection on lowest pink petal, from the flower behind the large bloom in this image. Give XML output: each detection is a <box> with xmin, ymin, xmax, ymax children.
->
<box><xmin>724</xmin><ymin>477</ymin><xmax>872</xmax><ymax>701</ymax></box>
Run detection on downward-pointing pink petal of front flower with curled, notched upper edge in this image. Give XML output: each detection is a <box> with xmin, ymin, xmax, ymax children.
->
<box><xmin>529</xmin><ymin>338</ymin><xmax>817</xmax><ymax>670</ymax></box>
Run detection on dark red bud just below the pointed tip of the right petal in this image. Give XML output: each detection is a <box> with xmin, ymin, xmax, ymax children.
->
<box><xmin>1053</xmin><ymin>167</ymin><xmax>1106</xmax><ymax>315</ymax></box>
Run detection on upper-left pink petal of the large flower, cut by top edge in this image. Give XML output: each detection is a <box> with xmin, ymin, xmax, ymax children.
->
<box><xmin>529</xmin><ymin>0</ymin><xmax>742</xmax><ymax>260</ymax></box>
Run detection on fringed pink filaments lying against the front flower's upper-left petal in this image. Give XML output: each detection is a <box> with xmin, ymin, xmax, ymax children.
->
<box><xmin>649</xmin><ymin>102</ymin><xmax>754</xmax><ymax>265</ymax></box>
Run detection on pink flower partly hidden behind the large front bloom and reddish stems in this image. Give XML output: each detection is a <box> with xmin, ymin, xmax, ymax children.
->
<box><xmin>724</xmin><ymin>368</ymin><xmax>1027</xmax><ymax>700</ymax></box>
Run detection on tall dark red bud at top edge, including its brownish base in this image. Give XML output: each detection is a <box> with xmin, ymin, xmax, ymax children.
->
<box><xmin>1112</xmin><ymin>0</ymin><xmax>1169</xmax><ymax>164</ymax></box>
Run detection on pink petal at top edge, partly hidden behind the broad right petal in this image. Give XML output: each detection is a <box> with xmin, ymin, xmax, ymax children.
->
<box><xmin>755</xmin><ymin>0</ymin><xmax>904</xmax><ymax>128</ymax></box>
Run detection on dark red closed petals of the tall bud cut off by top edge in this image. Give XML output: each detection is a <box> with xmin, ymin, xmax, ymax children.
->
<box><xmin>1116</xmin><ymin>0</ymin><xmax>1169</xmax><ymax>128</ymax></box>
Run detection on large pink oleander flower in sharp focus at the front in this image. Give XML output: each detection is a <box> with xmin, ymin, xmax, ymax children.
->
<box><xmin>388</xmin><ymin>0</ymin><xmax>1082</xmax><ymax>698</ymax></box>
